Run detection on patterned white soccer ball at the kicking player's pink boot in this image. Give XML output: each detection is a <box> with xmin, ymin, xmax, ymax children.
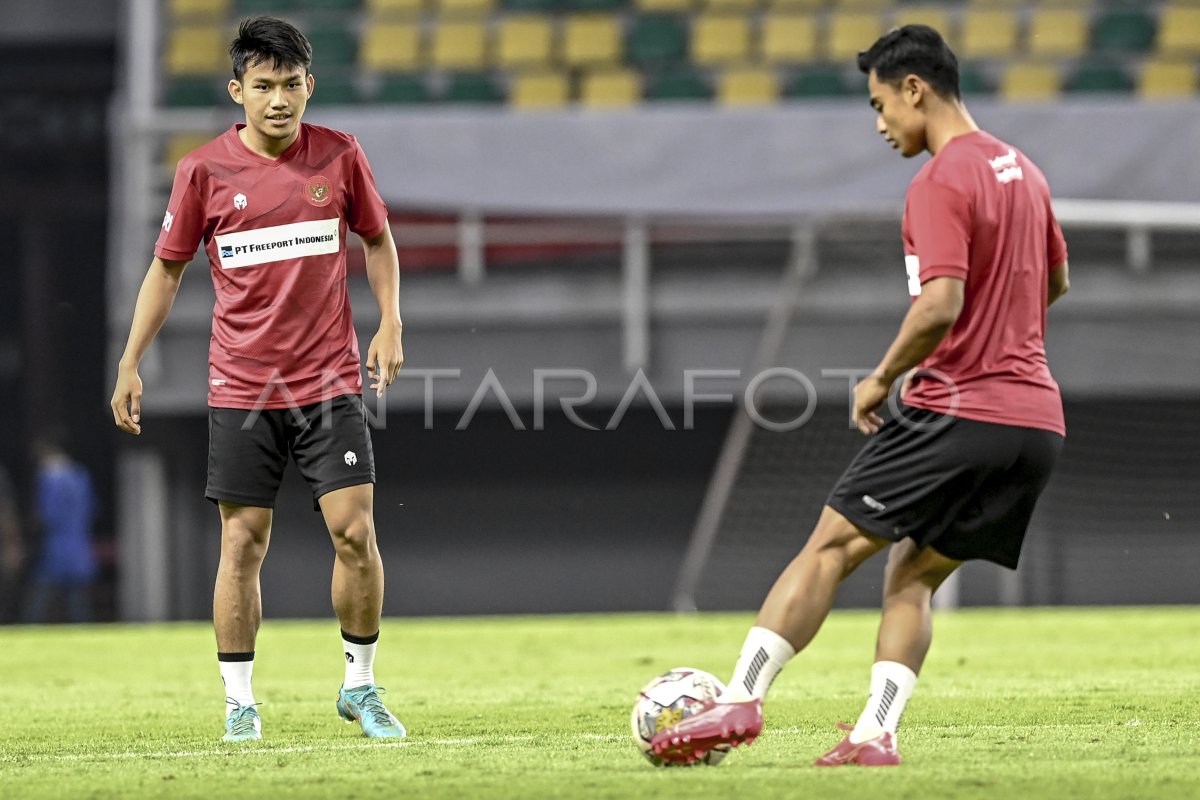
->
<box><xmin>630</xmin><ymin>667</ymin><xmax>730</xmax><ymax>766</ymax></box>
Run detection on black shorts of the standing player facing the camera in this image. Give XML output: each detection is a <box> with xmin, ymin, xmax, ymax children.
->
<box><xmin>204</xmin><ymin>395</ymin><xmax>374</xmax><ymax>509</ymax></box>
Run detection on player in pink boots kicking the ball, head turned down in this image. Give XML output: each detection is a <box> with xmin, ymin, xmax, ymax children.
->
<box><xmin>653</xmin><ymin>25</ymin><xmax>1067</xmax><ymax>766</ymax></box>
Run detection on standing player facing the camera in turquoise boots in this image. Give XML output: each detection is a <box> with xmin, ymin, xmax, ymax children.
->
<box><xmin>112</xmin><ymin>18</ymin><xmax>404</xmax><ymax>741</ymax></box>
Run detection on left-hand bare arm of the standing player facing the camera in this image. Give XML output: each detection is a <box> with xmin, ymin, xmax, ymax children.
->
<box><xmin>109</xmin><ymin>257</ymin><xmax>187</xmax><ymax>435</ymax></box>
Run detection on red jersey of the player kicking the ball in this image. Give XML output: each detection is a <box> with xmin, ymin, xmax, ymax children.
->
<box><xmin>904</xmin><ymin>131</ymin><xmax>1067</xmax><ymax>435</ymax></box>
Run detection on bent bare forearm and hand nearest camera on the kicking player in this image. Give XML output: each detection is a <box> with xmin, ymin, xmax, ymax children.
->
<box><xmin>854</xmin><ymin>277</ymin><xmax>965</xmax><ymax>434</ymax></box>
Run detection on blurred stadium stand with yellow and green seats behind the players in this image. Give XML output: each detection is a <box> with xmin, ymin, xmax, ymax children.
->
<box><xmin>0</xmin><ymin>0</ymin><xmax>1200</xmax><ymax>621</ymax></box>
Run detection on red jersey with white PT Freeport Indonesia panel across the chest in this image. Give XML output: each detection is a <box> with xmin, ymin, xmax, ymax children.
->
<box><xmin>154</xmin><ymin>122</ymin><xmax>388</xmax><ymax>409</ymax></box>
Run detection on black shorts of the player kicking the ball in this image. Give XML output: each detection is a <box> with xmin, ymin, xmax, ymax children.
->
<box><xmin>828</xmin><ymin>407</ymin><xmax>1063</xmax><ymax>570</ymax></box>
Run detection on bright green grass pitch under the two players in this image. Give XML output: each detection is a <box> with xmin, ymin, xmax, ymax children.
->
<box><xmin>0</xmin><ymin>608</ymin><xmax>1200</xmax><ymax>800</ymax></box>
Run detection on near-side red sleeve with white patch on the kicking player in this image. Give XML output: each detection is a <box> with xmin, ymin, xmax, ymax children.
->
<box><xmin>905</xmin><ymin>180</ymin><xmax>971</xmax><ymax>283</ymax></box>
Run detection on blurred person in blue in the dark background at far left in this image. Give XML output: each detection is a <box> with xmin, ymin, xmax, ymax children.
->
<box><xmin>24</xmin><ymin>437</ymin><xmax>98</xmax><ymax>622</ymax></box>
